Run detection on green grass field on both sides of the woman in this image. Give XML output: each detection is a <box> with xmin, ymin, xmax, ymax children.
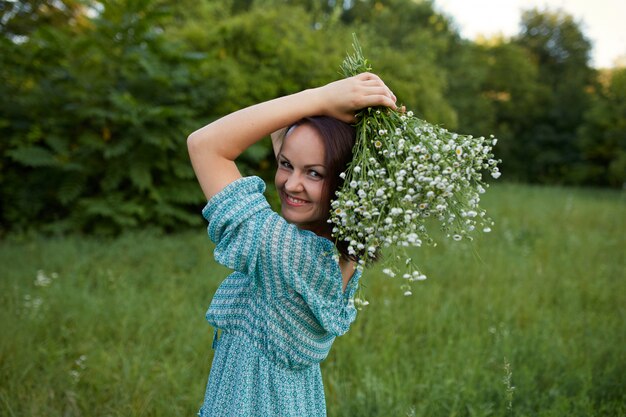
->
<box><xmin>0</xmin><ymin>184</ymin><xmax>626</xmax><ymax>417</ymax></box>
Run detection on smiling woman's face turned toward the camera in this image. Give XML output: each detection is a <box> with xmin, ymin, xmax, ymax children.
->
<box><xmin>275</xmin><ymin>124</ymin><xmax>329</xmax><ymax>235</ymax></box>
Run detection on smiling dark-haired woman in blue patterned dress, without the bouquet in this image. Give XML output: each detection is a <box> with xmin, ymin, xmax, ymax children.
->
<box><xmin>187</xmin><ymin>73</ymin><xmax>396</xmax><ymax>417</ymax></box>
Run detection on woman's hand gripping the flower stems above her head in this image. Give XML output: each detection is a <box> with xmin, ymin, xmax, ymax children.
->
<box><xmin>317</xmin><ymin>72</ymin><xmax>396</xmax><ymax>123</ymax></box>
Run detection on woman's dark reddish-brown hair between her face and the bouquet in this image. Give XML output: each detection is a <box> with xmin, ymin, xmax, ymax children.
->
<box><xmin>287</xmin><ymin>116</ymin><xmax>358</xmax><ymax>261</ymax></box>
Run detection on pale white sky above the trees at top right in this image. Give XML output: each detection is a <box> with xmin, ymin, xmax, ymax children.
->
<box><xmin>434</xmin><ymin>0</ymin><xmax>626</xmax><ymax>68</ymax></box>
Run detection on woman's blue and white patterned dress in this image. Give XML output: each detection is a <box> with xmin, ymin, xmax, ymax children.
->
<box><xmin>198</xmin><ymin>177</ymin><xmax>360</xmax><ymax>417</ymax></box>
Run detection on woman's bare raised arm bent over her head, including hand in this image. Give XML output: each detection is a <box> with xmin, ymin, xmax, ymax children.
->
<box><xmin>187</xmin><ymin>73</ymin><xmax>395</xmax><ymax>200</ymax></box>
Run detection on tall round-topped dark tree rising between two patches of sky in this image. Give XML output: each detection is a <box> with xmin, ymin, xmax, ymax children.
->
<box><xmin>515</xmin><ymin>9</ymin><xmax>595</xmax><ymax>183</ymax></box>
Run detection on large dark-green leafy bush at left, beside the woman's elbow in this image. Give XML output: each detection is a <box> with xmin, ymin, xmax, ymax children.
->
<box><xmin>0</xmin><ymin>0</ymin><xmax>205</xmax><ymax>232</ymax></box>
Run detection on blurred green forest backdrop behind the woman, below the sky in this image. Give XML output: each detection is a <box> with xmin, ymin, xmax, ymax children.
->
<box><xmin>0</xmin><ymin>0</ymin><xmax>626</xmax><ymax>234</ymax></box>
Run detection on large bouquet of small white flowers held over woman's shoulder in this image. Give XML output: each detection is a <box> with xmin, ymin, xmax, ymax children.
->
<box><xmin>329</xmin><ymin>37</ymin><xmax>501</xmax><ymax>295</ymax></box>
